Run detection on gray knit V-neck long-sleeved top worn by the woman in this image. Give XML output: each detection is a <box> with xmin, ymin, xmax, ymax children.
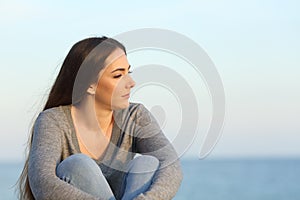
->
<box><xmin>28</xmin><ymin>103</ymin><xmax>182</xmax><ymax>200</ymax></box>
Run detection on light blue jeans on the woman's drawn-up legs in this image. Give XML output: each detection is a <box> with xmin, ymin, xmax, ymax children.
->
<box><xmin>56</xmin><ymin>154</ymin><xmax>159</xmax><ymax>200</ymax></box>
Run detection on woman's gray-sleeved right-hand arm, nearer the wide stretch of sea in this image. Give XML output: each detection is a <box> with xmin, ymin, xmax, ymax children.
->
<box><xmin>136</xmin><ymin>105</ymin><xmax>183</xmax><ymax>200</ymax></box>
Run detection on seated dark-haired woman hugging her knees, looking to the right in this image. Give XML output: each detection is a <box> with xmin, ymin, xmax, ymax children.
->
<box><xmin>19</xmin><ymin>37</ymin><xmax>182</xmax><ymax>200</ymax></box>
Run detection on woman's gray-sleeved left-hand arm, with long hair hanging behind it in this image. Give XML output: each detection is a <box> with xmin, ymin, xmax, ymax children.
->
<box><xmin>28</xmin><ymin>112</ymin><xmax>96</xmax><ymax>200</ymax></box>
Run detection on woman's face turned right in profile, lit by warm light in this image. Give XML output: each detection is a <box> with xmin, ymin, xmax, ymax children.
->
<box><xmin>95</xmin><ymin>48</ymin><xmax>135</xmax><ymax>110</ymax></box>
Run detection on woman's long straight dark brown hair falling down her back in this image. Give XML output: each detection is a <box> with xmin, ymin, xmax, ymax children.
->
<box><xmin>18</xmin><ymin>36</ymin><xmax>126</xmax><ymax>200</ymax></box>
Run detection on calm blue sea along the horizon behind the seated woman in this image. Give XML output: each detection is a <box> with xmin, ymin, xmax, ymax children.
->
<box><xmin>0</xmin><ymin>158</ymin><xmax>300</xmax><ymax>200</ymax></box>
